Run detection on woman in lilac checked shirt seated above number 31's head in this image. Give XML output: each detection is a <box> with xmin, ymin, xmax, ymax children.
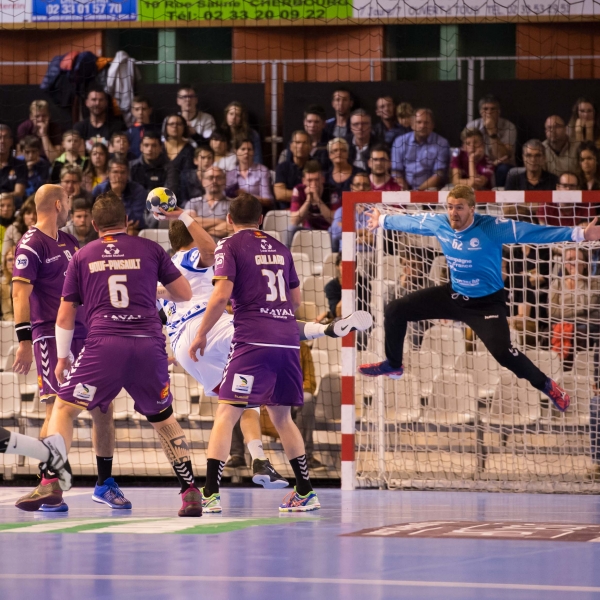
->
<box><xmin>226</xmin><ymin>140</ymin><xmax>275</xmax><ymax>211</ymax></box>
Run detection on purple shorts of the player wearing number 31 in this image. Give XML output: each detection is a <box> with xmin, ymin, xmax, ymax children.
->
<box><xmin>219</xmin><ymin>342</ymin><xmax>304</xmax><ymax>406</ymax></box>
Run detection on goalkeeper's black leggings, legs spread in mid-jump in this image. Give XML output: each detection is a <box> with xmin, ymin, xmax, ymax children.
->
<box><xmin>384</xmin><ymin>285</ymin><xmax>547</xmax><ymax>390</ymax></box>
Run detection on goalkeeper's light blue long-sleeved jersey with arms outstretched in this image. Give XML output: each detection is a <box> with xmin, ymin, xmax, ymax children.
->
<box><xmin>382</xmin><ymin>213</ymin><xmax>582</xmax><ymax>298</ymax></box>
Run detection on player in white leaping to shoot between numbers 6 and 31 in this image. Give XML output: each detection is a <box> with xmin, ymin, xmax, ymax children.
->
<box><xmin>157</xmin><ymin>209</ymin><xmax>373</xmax><ymax>488</ymax></box>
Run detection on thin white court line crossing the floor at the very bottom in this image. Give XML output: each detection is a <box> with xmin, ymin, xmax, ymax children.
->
<box><xmin>0</xmin><ymin>573</ymin><xmax>600</xmax><ymax>593</ymax></box>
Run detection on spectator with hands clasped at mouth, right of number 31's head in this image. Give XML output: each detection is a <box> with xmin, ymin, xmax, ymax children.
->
<box><xmin>289</xmin><ymin>160</ymin><xmax>339</xmax><ymax>241</ymax></box>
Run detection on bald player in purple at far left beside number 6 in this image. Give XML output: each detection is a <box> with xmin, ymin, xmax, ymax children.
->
<box><xmin>13</xmin><ymin>185</ymin><xmax>120</xmax><ymax>512</ymax></box>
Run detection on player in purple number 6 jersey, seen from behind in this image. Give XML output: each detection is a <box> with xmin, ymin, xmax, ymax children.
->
<box><xmin>42</xmin><ymin>192</ymin><xmax>202</xmax><ymax>517</ymax></box>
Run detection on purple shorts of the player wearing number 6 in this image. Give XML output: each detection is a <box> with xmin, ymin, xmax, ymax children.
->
<box><xmin>58</xmin><ymin>336</ymin><xmax>173</xmax><ymax>416</ymax></box>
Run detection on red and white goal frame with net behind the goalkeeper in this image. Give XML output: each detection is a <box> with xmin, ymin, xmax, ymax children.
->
<box><xmin>340</xmin><ymin>191</ymin><xmax>600</xmax><ymax>493</ymax></box>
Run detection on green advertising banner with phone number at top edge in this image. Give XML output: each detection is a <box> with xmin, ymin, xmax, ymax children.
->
<box><xmin>138</xmin><ymin>0</ymin><xmax>352</xmax><ymax>22</ymax></box>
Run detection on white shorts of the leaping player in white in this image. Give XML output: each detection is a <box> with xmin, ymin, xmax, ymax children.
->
<box><xmin>173</xmin><ymin>314</ymin><xmax>233</xmax><ymax>396</ymax></box>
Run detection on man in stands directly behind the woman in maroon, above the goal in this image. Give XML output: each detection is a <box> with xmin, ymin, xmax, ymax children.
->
<box><xmin>467</xmin><ymin>94</ymin><xmax>517</xmax><ymax>187</ymax></box>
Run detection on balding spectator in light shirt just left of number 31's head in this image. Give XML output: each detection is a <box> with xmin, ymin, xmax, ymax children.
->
<box><xmin>185</xmin><ymin>166</ymin><xmax>233</xmax><ymax>239</ymax></box>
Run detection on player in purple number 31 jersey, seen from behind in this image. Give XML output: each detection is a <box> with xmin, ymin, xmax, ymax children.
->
<box><xmin>189</xmin><ymin>194</ymin><xmax>320</xmax><ymax>512</ymax></box>
